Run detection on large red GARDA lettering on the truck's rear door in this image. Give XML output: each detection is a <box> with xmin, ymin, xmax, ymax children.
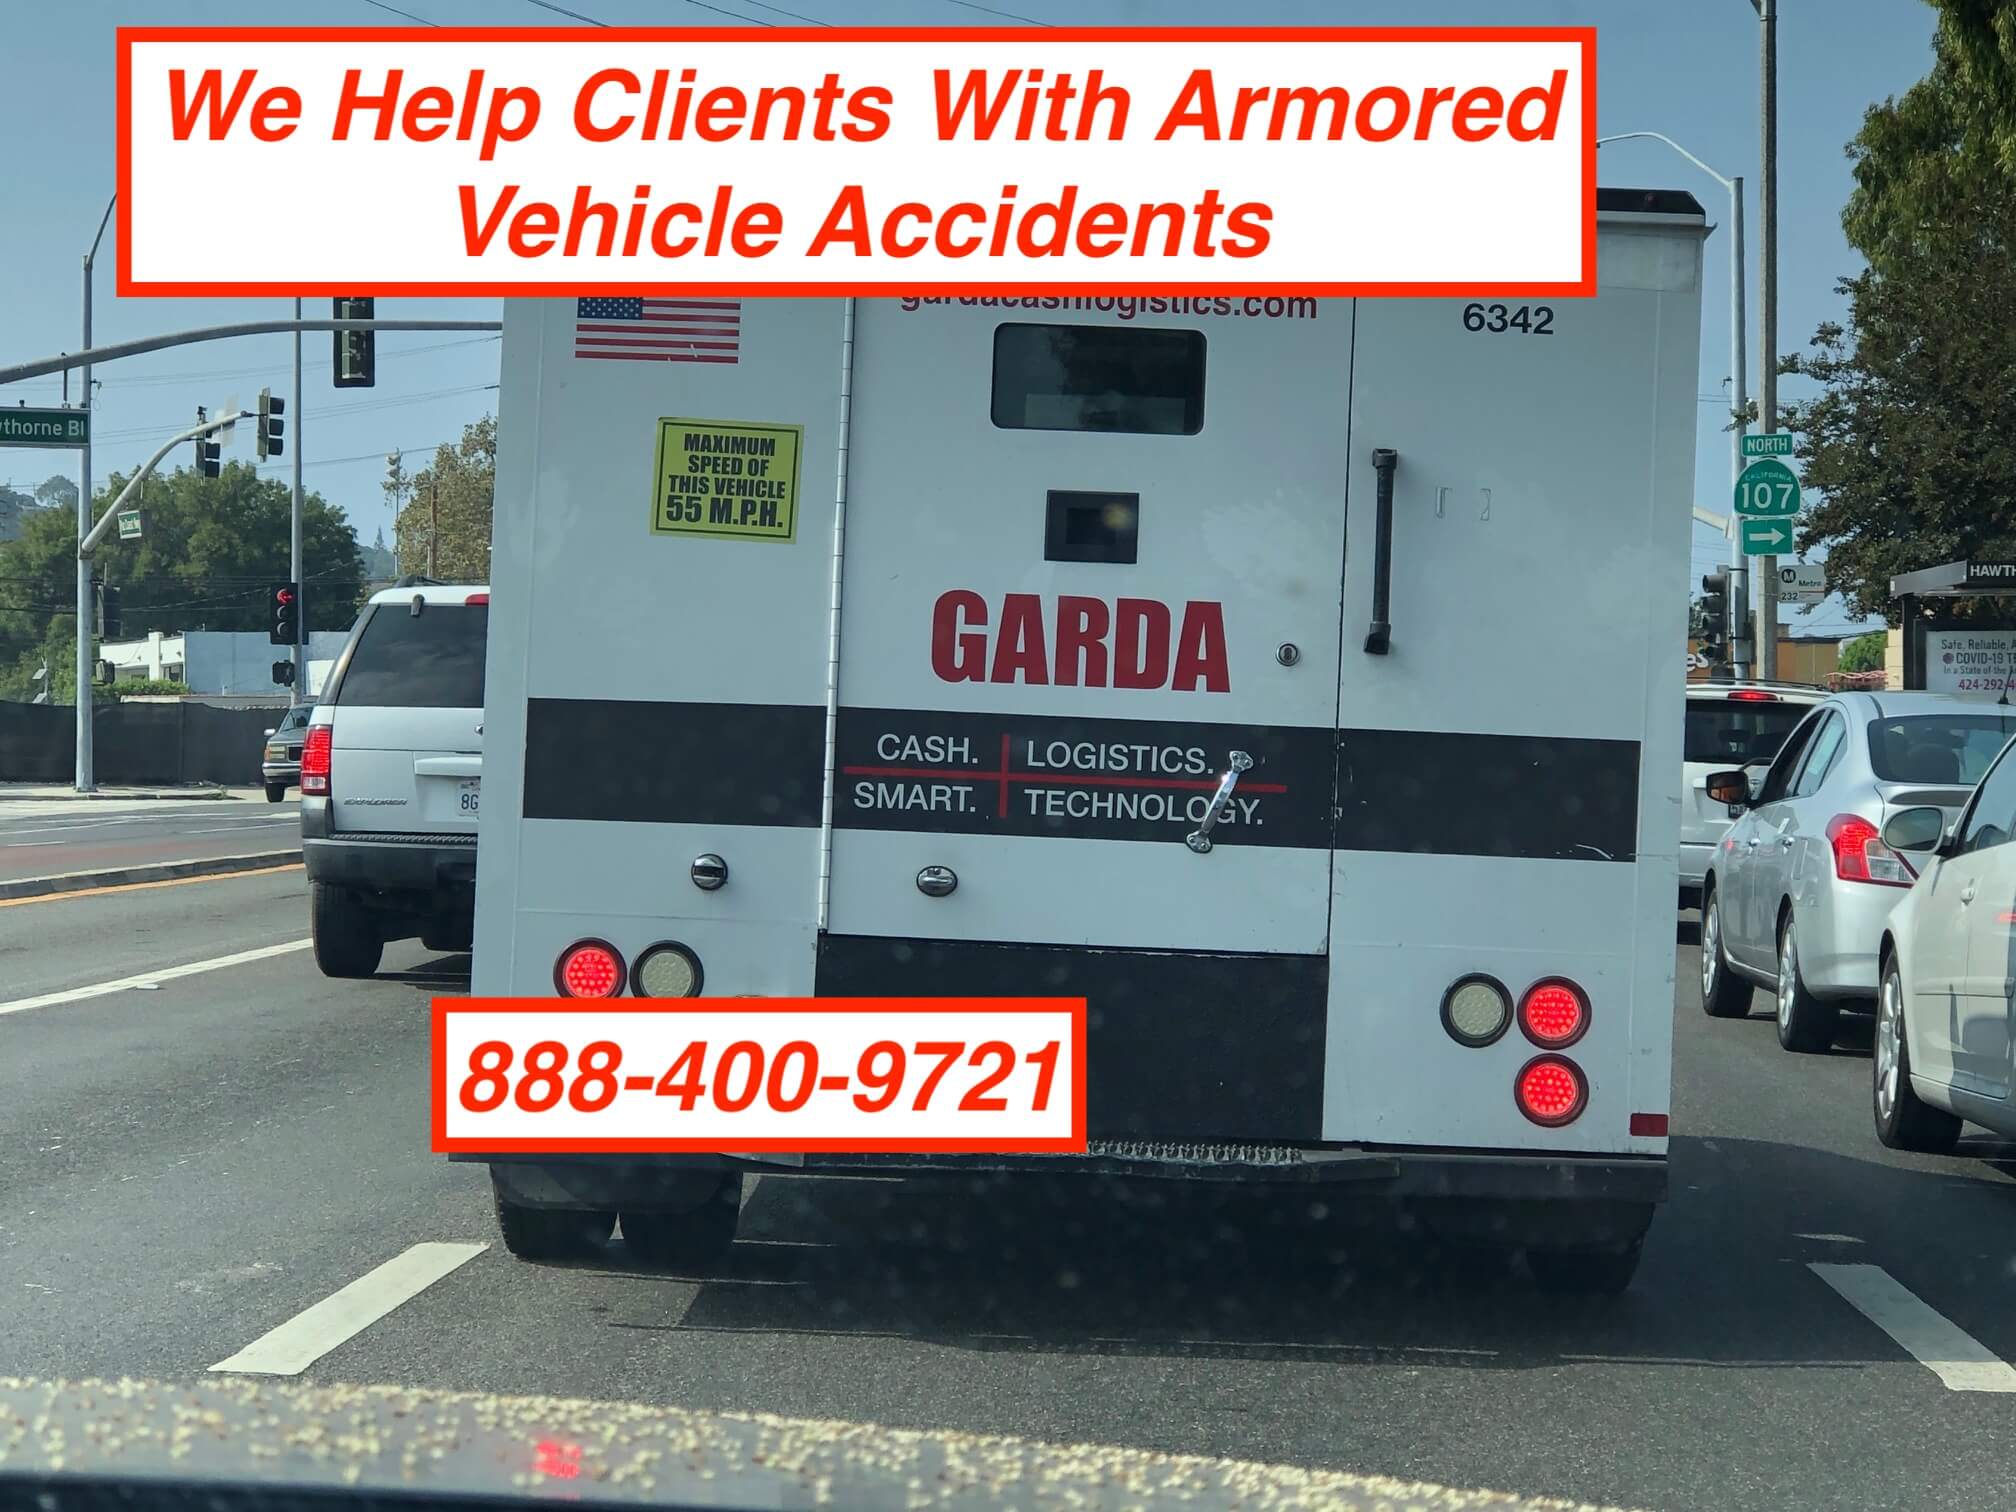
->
<box><xmin>931</xmin><ymin>589</ymin><xmax>1232</xmax><ymax>694</ymax></box>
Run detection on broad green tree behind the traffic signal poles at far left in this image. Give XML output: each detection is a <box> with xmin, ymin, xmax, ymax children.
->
<box><xmin>0</xmin><ymin>462</ymin><xmax>363</xmax><ymax>683</ymax></box>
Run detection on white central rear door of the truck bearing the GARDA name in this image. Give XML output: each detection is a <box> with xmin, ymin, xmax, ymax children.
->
<box><xmin>827</xmin><ymin>298</ymin><xmax>1353</xmax><ymax>959</ymax></box>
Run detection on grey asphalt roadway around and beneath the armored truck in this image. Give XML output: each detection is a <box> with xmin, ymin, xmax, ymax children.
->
<box><xmin>0</xmin><ymin>873</ymin><xmax>2016</xmax><ymax>1508</ymax></box>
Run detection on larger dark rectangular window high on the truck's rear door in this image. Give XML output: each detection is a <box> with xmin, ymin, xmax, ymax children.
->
<box><xmin>994</xmin><ymin>325</ymin><xmax>1204</xmax><ymax>435</ymax></box>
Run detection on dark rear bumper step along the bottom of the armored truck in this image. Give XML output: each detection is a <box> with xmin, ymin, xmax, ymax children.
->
<box><xmin>471</xmin><ymin>1141</ymin><xmax>1667</xmax><ymax>1210</ymax></box>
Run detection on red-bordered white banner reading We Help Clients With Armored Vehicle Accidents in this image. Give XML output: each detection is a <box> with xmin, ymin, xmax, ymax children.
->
<box><xmin>119</xmin><ymin>28</ymin><xmax>1595</xmax><ymax>296</ymax></box>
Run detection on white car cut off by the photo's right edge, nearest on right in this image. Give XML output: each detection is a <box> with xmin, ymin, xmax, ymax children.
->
<box><xmin>1873</xmin><ymin>742</ymin><xmax>2016</xmax><ymax>1151</ymax></box>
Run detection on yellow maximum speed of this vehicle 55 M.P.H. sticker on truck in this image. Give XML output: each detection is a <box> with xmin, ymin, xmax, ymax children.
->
<box><xmin>651</xmin><ymin>419</ymin><xmax>804</xmax><ymax>540</ymax></box>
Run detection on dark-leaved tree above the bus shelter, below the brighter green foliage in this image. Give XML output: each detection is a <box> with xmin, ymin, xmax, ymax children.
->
<box><xmin>1784</xmin><ymin>185</ymin><xmax>2016</xmax><ymax>615</ymax></box>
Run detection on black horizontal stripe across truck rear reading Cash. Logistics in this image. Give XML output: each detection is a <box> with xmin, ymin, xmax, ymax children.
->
<box><xmin>524</xmin><ymin>698</ymin><xmax>1639</xmax><ymax>863</ymax></box>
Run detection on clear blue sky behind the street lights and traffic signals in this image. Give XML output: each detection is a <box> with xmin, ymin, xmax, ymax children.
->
<box><xmin>0</xmin><ymin>0</ymin><xmax>1933</xmax><ymax>633</ymax></box>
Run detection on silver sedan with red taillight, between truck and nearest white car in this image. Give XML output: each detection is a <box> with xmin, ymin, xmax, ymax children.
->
<box><xmin>1702</xmin><ymin>694</ymin><xmax>2016</xmax><ymax>1050</ymax></box>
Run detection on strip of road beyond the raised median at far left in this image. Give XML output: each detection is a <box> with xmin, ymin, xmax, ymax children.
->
<box><xmin>0</xmin><ymin>792</ymin><xmax>300</xmax><ymax>883</ymax></box>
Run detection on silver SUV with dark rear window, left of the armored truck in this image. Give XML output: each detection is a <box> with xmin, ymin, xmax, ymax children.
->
<box><xmin>300</xmin><ymin>583</ymin><xmax>490</xmax><ymax>976</ymax></box>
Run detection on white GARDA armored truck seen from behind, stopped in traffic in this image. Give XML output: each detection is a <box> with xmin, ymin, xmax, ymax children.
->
<box><xmin>474</xmin><ymin>190</ymin><xmax>1706</xmax><ymax>1290</ymax></box>
